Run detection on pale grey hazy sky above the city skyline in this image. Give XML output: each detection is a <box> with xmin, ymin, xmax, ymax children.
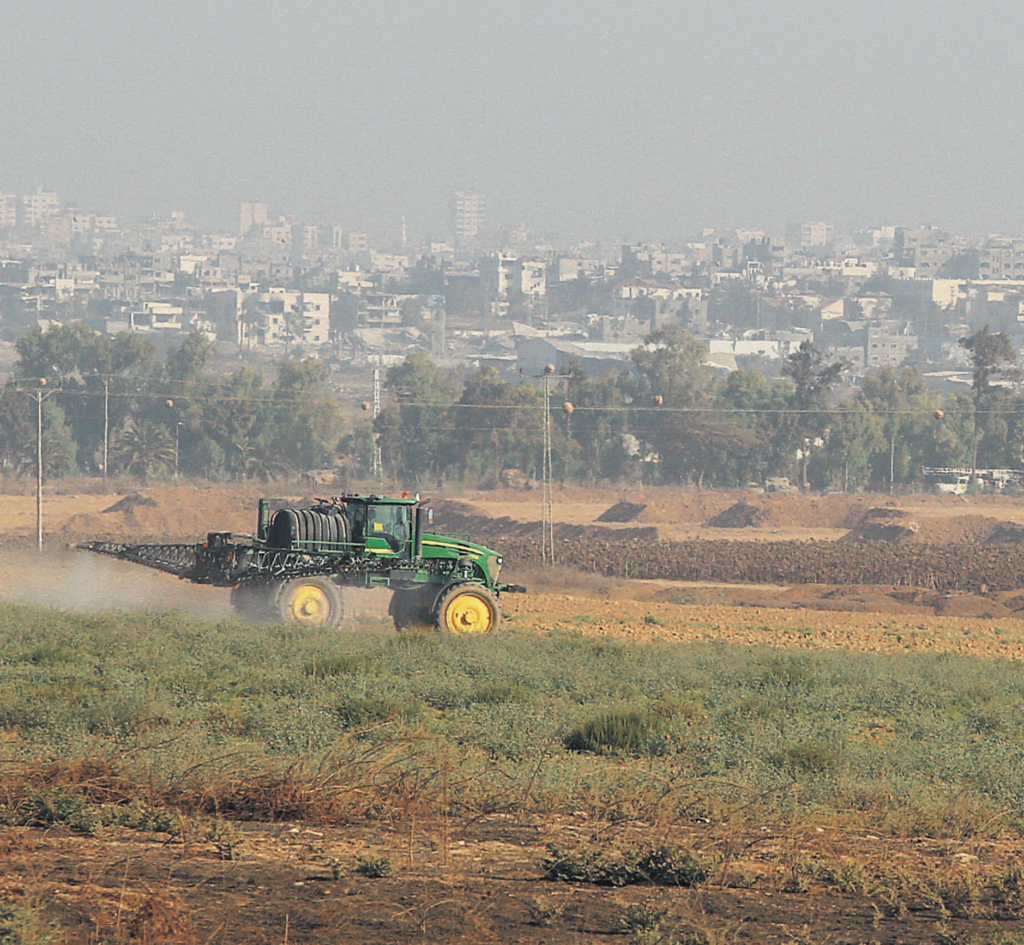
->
<box><xmin>0</xmin><ymin>0</ymin><xmax>1024</xmax><ymax>240</ymax></box>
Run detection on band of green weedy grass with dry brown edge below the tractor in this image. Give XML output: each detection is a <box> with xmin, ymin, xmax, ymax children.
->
<box><xmin>0</xmin><ymin>604</ymin><xmax>1024</xmax><ymax>837</ymax></box>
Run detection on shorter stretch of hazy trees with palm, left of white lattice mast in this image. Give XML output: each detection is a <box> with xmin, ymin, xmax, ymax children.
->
<box><xmin>0</xmin><ymin>324</ymin><xmax>352</xmax><ymax>481</ymax></box>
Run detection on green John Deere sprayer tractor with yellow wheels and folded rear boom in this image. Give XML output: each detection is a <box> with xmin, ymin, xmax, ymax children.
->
<box><xmin>77</xmin><ymin>495</ymin><xmax>526</xmax><ymax>634</ymax></box>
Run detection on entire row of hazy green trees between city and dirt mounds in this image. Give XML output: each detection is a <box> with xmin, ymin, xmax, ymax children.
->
<box><xmin>0</xmin><ymin>324</ymin><xmax>1024</xmax><ymax>489</ymax></box>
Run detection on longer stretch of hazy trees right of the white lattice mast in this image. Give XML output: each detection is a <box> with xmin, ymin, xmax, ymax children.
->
<box><xmin>377</xmin><ymin>327</ymin><xmax>1024</xmax><ymax>489</ymax></box>
